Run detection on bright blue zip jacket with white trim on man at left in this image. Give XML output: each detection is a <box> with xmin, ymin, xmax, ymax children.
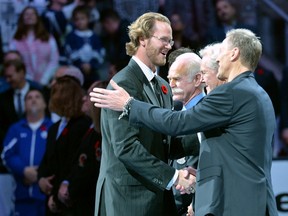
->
<box><xmin>1</xmin><ymin>118</ymin><xmax>52</xmax><ymax>200</ymax></box>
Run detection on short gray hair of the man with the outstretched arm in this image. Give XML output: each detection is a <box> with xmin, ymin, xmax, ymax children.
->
<box><xmin>226</xmin><ymin>29</ymin><xmax>262</xmax><ymax>71</ymax></box>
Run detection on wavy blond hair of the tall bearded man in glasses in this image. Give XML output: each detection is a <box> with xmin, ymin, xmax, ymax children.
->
<box><xmin>126</xmin><ymin>12</ymin><xmax>170</xmax><ymax>56</ymax></box>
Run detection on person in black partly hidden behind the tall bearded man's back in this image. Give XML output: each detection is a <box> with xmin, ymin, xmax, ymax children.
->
<box><xmin>58</xmin><ymin>81</ymin><xmax>108</xmax><ymax>216</ymax></box>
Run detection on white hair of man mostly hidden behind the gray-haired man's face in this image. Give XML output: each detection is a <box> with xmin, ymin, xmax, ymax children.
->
<box><xmin>199</xmin><ymin>43</ymin><xmax>221</xmax><ymax>71</ymax></box>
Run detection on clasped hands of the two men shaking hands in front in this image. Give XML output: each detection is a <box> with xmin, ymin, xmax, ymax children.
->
<box><xmin>174</xmin><ymin>167</ymin><xmax>196</xmax><ymax>194</ymax></box>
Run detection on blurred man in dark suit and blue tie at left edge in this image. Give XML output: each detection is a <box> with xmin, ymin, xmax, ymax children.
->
<box><xmin>0</xmin><ymin>60</ymin><xmax>41</xmax><ymax>215</ymax></box>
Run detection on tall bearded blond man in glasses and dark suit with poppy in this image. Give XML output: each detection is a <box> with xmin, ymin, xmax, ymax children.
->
<box><xmin>95</xmin><ymin>13</ymin><xmax>194</xmax><ymax>216</ymax></box>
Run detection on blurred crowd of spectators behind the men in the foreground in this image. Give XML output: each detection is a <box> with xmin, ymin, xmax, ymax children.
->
<box><xmin>0</xmin><ymin>0</ymin><xmax>288</xmax><ymax>216</ymax></box>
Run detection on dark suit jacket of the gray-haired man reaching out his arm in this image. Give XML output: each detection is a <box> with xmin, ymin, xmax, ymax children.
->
<box><xmin>130</xmin><ymin>72</ymin><xmax>277</xmax><ymax>216</ymax></box>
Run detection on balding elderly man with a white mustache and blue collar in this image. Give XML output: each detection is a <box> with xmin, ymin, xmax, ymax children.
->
<box><xmin>168</xmin><ymin>51</ymin><xmax>205</xmax><ymax>215</ymax></box>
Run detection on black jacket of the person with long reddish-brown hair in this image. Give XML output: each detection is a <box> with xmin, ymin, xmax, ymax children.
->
<box><xmin>38</xmin><ymin>116</ymin><xmax>91</xmax><ymax>213</ymax></box>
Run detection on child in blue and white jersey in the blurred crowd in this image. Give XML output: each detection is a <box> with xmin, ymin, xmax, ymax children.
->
<box><xmin>65</xmin><ymin>6</ymin><xmax>105</xmax><ymax>89</ymax></box>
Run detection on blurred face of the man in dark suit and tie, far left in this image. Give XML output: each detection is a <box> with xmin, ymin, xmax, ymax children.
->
<box><xmin>4</xmin><ymin>65</ymin><xmax>25</xmax><ymax>89</ymax></box>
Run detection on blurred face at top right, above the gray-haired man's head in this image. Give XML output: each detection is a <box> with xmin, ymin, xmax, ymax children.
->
<box><xmin>216</xmin><ymin>1</ymin><xmax>236</xmax><ymax>22</ymax></box>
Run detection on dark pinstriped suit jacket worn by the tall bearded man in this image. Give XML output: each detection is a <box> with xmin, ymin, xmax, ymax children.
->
<box><xmin>95</xmin><ymin>59</ymin><xmax>176</xmax><ymax>216</ymax></box>
